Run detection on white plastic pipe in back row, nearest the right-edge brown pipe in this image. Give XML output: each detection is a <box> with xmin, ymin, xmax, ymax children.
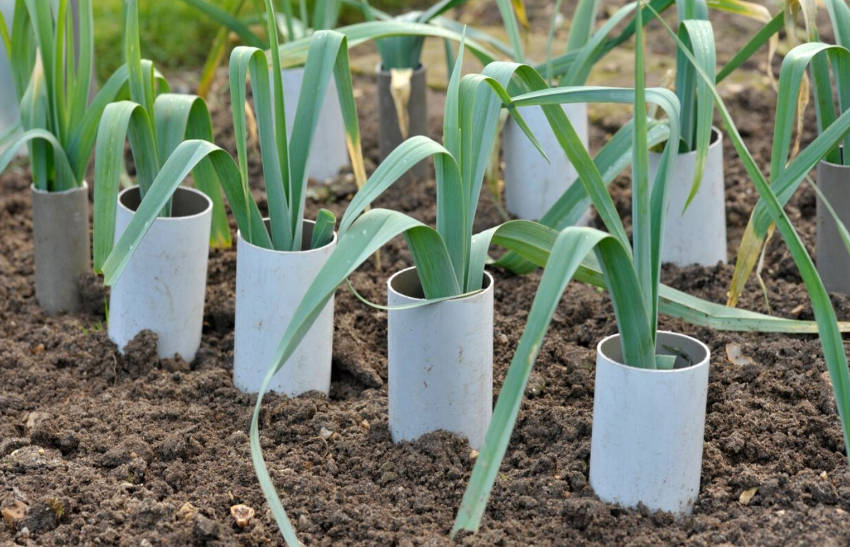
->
<box><xmin>649</xmin><ymin>128</ymin><xmax>726</xmax><ymax>266</ymax></box>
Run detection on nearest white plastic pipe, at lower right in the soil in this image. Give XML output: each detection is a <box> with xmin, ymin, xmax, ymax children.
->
<box><xmin>590</xmin><ymin>331</ymin><xmax>710</xmax><ymax>514</ymax></box>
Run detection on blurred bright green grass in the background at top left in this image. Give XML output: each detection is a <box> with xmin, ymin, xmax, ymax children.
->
<box><xmin>93</xmin><ymin>0</ymin><xmax>430</xmax><ymax>82</ymax></box>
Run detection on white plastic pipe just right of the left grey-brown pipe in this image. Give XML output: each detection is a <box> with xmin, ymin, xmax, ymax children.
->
<box><xmin>108</xmin><ymin>186</ymin><xmax>212</xmax><ymax>362</ymax></box>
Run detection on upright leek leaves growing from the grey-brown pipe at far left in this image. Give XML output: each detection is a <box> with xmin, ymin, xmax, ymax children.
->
<box><xmin>0</xmin><ymin>0</ymin><xmax>127</xmax><ymax>192</ymax></box>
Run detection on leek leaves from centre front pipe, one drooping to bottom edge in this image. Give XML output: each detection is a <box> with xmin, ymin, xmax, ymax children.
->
<box><xmin>242</xmin><ymin>36</ymin><xmax>589</xmax><ymax>545</ymax></box>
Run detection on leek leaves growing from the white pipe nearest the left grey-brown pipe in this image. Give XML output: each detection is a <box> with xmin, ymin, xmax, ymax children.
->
<box><xmin>94</xmin><ymin>0</ymin><xmax>230</xmax><ymax>273</ymax></box>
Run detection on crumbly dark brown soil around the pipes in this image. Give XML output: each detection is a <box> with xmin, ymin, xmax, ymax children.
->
<box><xmin>0</xmin><ymin>8</ymin><xmax>850</xmax><ymax>545</ymax></box>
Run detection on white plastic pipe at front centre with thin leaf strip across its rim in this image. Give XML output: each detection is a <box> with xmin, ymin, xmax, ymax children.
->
<box><xmin>387</xmin><ymin>268</ymin><xmax>493</xmax><ymax>449</ymax></box>
